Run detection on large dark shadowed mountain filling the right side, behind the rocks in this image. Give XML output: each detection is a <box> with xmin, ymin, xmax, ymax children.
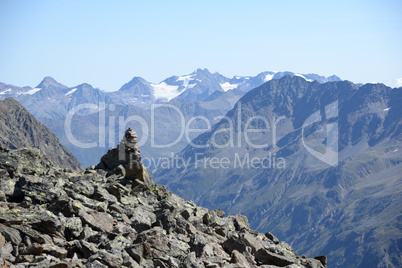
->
<box><xmin>154</xmin><ymin>76</ymin><xmax>402</xmax><ymax>267</ymax></box>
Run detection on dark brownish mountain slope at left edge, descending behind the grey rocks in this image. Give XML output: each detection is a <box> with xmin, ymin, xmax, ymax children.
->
<box><xmin>0</xmin><ymin>98</ymin><xmax>81</xmax><ymax>170</ymax></box>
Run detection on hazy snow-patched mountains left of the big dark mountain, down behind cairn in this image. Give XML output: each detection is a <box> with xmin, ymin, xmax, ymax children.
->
<box><xmin>0</xmin><ymin>69</ymin><xmax>340</xmax><ymax>166</ymax></box>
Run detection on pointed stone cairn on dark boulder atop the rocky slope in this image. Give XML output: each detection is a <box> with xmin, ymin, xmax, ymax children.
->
<box><xmin>95</xmin><ymin>128</ymin><xmax>153</xmax><ymax>187</ymax></box>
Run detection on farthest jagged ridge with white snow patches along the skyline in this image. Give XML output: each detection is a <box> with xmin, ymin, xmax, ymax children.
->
<box><xmin>0</xmin><ymin>69</ymin><xmax>341</xmax><ymax>112</ymax></box>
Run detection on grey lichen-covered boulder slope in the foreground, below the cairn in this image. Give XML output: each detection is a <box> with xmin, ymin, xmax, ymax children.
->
<box><xmin>0</xmin><ymin>146</ymin><xmax>326</xmax><ymax>268</ymax></box>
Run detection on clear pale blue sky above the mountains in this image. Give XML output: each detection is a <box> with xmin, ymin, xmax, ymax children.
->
<box><xmin>0</xmin><ymin>0</ymin><xmax>402</xmax><ymax>91</ymax></box>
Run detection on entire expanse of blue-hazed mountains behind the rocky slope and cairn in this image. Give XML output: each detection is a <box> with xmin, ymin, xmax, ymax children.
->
<box><xmin>0</xmin><ymin>69</ymin><xmax>402</xmax><ymax>267</ymax></box>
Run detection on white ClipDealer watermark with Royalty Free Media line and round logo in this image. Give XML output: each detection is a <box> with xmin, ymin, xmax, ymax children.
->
<box><xmin>64</xmin><ymin>101</ymin><xmax>339</xmax><ymax>169</ymax></box>
